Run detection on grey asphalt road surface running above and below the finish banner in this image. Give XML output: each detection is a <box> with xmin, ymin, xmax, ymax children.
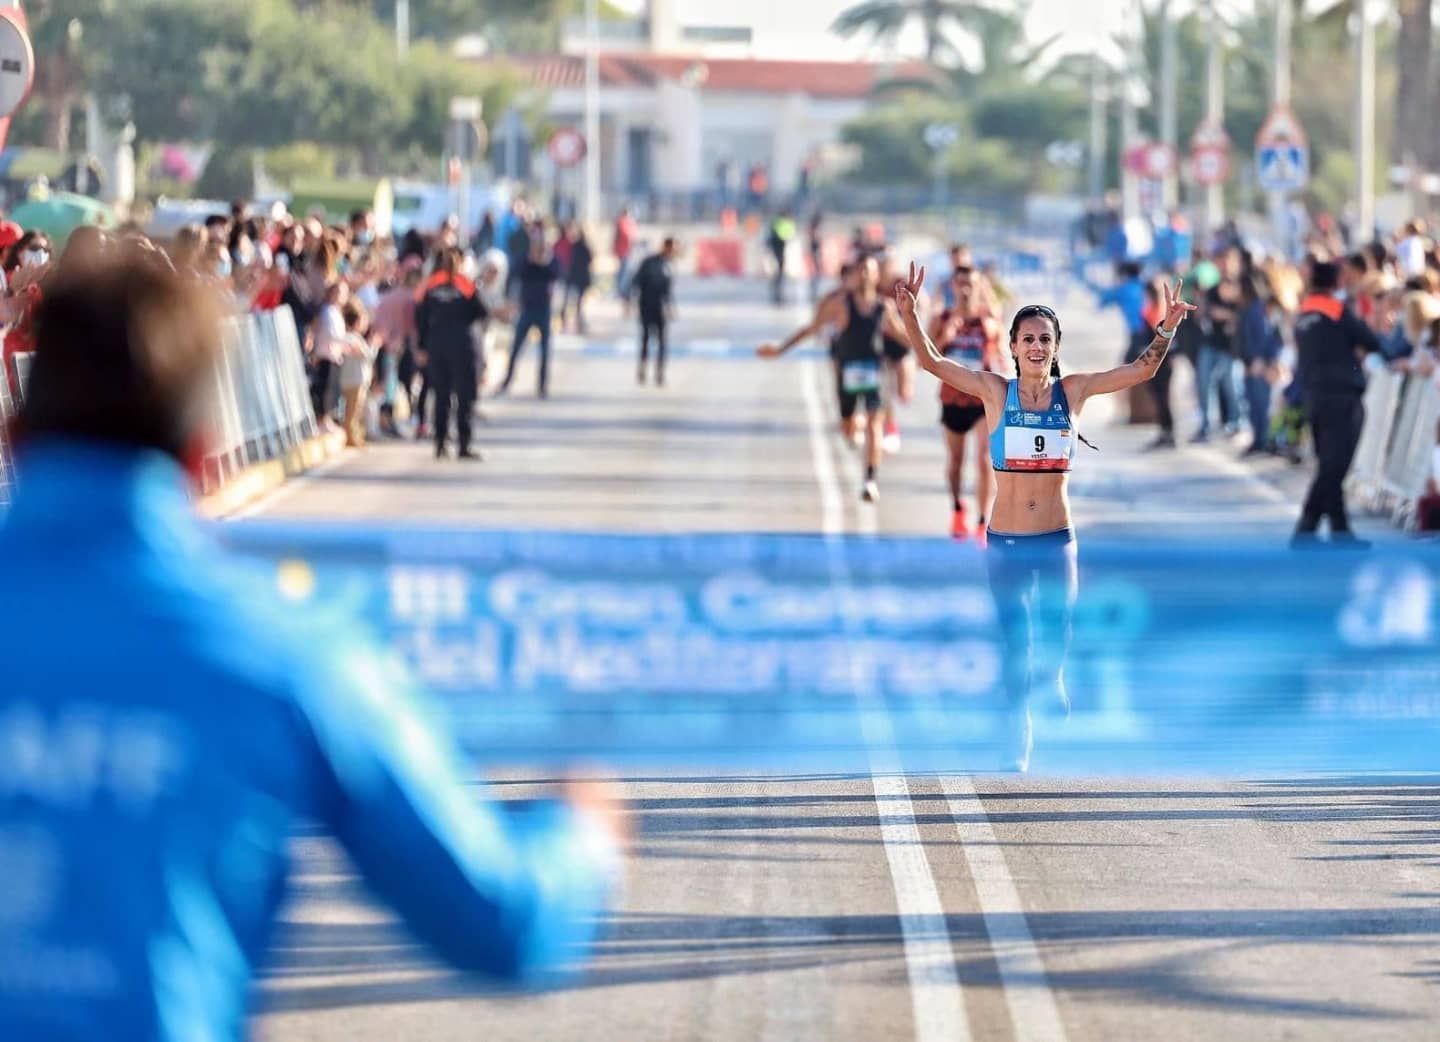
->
<box><xmin>255</xmin><ymin>272</ymin><xmax>1440</xmax><ymax>1042</ymax></box>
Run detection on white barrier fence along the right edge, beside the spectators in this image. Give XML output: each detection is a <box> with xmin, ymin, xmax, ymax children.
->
<box><xmin>1348</xmin><ymin>370</ymin><xmax>1440</xmax><ymax>528</ymax></box>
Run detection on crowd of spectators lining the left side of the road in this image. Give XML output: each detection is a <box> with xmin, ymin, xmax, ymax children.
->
<box><xmin>0</xmin><ymin>201</ymin><xmax>613</xmax><ymax>445</ymax></box>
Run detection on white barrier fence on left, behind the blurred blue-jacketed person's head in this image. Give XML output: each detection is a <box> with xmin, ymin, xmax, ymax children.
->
<box><xmin>0</xmin><ymin>308</ymin><xmax>320</xmax><ymax>507</ymax></box>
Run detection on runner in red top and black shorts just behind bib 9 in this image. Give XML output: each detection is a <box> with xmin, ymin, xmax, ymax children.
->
<box><xmin>930</xmin><ymin>266</ymin><xmax>1001</xmax><ymax>545</ymax></box>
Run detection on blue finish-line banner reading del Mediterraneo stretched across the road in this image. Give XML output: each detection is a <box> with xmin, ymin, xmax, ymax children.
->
<box><xmin>225</xmin><ymin>522</ymin><xmax>1440</xmax><ymax>776</ymax></box>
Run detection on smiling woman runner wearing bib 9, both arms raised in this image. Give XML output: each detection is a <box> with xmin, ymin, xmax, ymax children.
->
<box><xmin>894</xmin><ymin>263</ymin><xmax>1195</xmax><ymax>771</ymax></box>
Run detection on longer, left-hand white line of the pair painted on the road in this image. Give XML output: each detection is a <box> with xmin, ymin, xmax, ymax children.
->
<box><xmin>801</xmin><ymin>364</ymin><xmax>971</xmax><ymax>1042</ymax></box>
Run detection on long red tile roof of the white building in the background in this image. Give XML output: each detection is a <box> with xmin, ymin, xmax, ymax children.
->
<box><xmin>495</xmin><ymin>53</ymin><xmax>926</xmax><ymax>98</ymax></box>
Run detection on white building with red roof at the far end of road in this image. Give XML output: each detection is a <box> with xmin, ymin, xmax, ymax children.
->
<box><xmin>475</xmin><ymin>0</ymin><xmax>916</xmax><ymax>205</ymax></box>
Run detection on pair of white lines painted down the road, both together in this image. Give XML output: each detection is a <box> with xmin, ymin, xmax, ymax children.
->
<box><xmin>801</xmin><ymin>361</ymin><xmax>1066</xmax><ymax>1042</ymax></box>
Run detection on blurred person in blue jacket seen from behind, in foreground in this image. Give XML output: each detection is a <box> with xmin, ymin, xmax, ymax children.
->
<box><xmin>0</xmin><ymin>251</ymin><xmax>621</xmax><ymax>1042</ymax></box>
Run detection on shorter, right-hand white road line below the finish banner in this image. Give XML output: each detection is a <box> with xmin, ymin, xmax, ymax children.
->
<box><xmin>940</xmin><ymin>776</ymin><xmax>1066</xmax><ymax>1042</ymax></box>
